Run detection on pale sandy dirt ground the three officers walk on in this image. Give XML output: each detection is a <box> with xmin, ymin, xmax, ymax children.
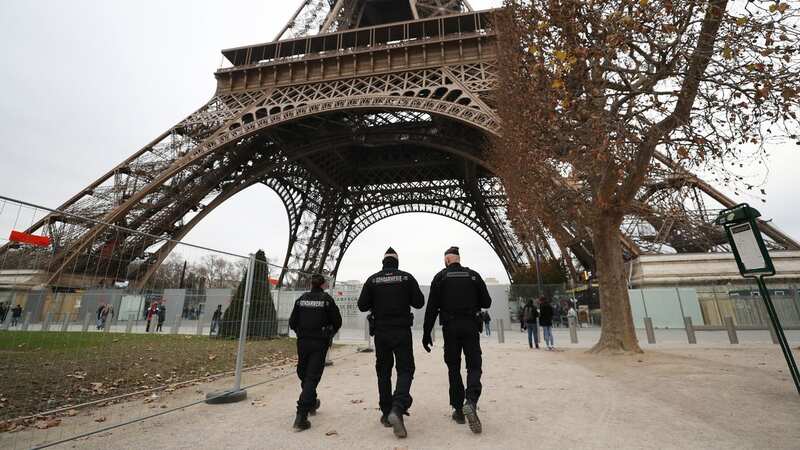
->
<box><xmin>0</xmin><ymin>340</ymin><xmax>800</xmax><ymax>449</ymax></box>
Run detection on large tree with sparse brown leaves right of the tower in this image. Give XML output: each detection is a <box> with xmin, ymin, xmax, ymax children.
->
<box><xmin>493</xmin><ymin>0</ymin><xmax>800</xmax><ymax>352</ymax></box>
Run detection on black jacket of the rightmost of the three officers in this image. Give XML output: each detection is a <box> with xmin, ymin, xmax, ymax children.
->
<box><xmin>424</xmin><ymin>263</ymin><xmax>492</xmax><ymax>333</ymax></box>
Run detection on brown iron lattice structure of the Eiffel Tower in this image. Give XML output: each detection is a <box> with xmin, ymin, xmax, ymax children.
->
<box><xmin>4</xmin><ymin>0</ymin><xmax>800</xmax><ymax>284</ymax></box>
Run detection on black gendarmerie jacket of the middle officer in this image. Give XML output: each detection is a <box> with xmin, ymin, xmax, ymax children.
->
<box><xmin>358</xmin><ymin>263</ymin><xmax>425</xmax><ymax>330</ymax></box>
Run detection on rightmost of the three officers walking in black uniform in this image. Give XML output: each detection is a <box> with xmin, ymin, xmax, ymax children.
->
<box><xmin>422</xmin><ymin>247</ymin><xmax>492</xmax><ymax>433</ymax></box>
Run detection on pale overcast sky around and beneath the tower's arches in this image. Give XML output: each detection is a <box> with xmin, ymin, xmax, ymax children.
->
<box><xmin>0</xmin><ymin>0</ymin><xmax>800</xmax><ymax>283</ymax></box>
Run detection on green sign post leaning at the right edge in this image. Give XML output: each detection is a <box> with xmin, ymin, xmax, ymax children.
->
<box><xmin>716</xmin><ymin>203</ymin><xmax>800</xmax><ymax>394</ymax></box>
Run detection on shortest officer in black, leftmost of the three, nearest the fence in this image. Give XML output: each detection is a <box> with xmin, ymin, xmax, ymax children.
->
<box><xmin>289</xmin><ymin>274</ymin><xmax>342</xmax><ymax>431</ymax></box>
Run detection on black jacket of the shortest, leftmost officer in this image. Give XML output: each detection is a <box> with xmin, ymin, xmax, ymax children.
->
<box><xmin>289</xmin><ymin>289</ymin><xmax>342</xmax><ymax>339</ymax></box>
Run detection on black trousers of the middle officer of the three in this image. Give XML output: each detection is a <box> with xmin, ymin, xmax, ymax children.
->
<box><xmin>375</xmin><ymin>328</ymin><xmax>415</xmax><ymax>414</ymax></box>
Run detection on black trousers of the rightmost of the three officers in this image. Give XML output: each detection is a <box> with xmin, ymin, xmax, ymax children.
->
<box><xmin>442</xmin><ymin>319</ymin><xmax>482</xmax><ymax>409</ymax></box>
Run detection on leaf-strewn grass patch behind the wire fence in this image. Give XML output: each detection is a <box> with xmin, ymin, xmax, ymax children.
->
<box><xmin>0</xmin><ymin>332</ymin><xmax>296</xmax><ymax>421</ymax></box>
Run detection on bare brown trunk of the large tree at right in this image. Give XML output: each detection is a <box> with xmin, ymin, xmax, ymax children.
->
<box><xmin>590</xmin><ymin>216</ymin><xmax>642</xmax><ymax>353</ymax></box>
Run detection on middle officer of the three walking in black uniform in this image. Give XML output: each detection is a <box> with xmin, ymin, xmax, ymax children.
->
<box><xmin>358</xmin><ymin>247</ymin><xmax>425</xmax><ymax>438</ymax></box>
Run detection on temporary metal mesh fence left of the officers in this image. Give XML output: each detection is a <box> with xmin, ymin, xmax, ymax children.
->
<box><xmin>0</xmin><ymin>197</ymin><xmax>340</xmax><ymax>449</ymax></box>
